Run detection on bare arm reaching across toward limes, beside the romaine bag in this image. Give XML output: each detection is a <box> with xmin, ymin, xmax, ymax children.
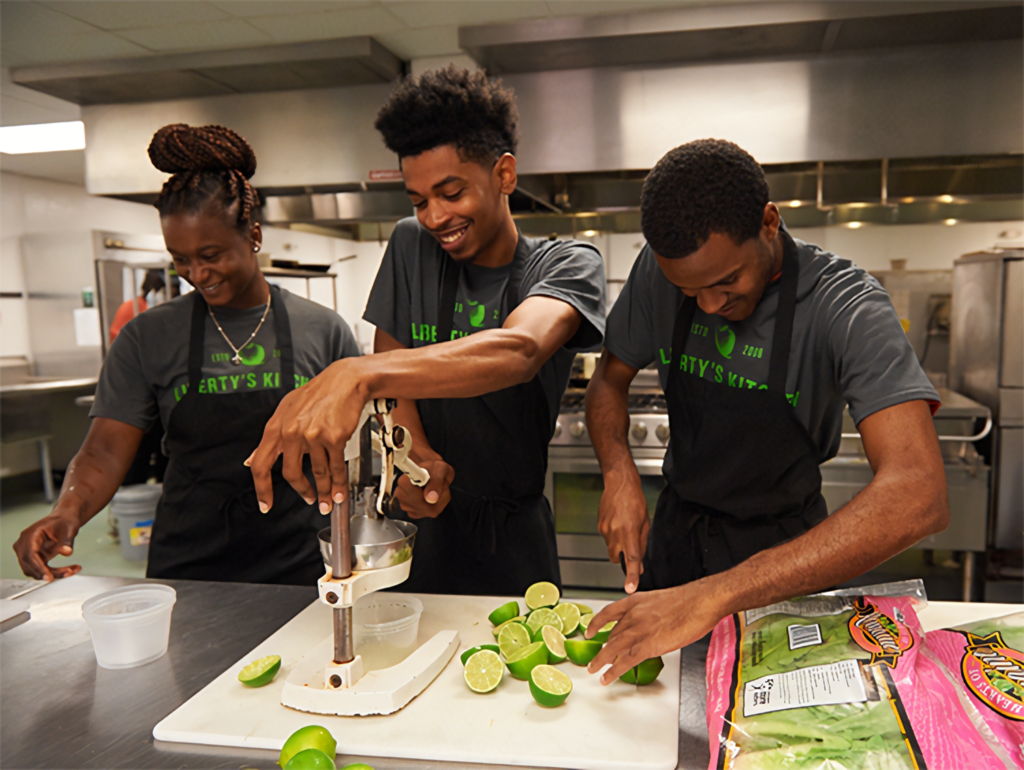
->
<box><xmin>589</xmin><ymin>400</ymin><xmax>949</xmax><ymax>684</ymax></box>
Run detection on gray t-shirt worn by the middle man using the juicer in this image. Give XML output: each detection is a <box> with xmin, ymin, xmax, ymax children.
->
<box><xmin>362</xmin><ymin>217</ymin><xmax>605</xmax><ymax>425</ymax></box>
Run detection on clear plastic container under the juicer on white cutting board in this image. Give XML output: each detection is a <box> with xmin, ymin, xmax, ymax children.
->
<box><xmin>352</xmin><ymin>593</ymin><xmax>423</xmax><ymax>671</ymax></box>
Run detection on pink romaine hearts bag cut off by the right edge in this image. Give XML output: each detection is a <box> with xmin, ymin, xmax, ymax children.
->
<box><xmin>928</xmin><ymin>612</ymin><xmax>1024</xmax><ymax>768</ymax></box>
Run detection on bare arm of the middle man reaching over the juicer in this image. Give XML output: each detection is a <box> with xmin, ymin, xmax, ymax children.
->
<box><xmin>248</xmin><ymin>296</ymin><xmax>583</xmax><ymax>512</ymax></box>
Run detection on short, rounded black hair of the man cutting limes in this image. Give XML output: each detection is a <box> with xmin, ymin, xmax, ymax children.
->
<box><xmin>640</xmin><ymin>139</ymin><xmax>768</xmax><ymax>259</ymax></box>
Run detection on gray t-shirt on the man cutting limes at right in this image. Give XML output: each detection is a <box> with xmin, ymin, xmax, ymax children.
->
<box><xmin>604</xmin><ymin>233</ymin><xmax>939</xmax><ymax>467</ymax></box>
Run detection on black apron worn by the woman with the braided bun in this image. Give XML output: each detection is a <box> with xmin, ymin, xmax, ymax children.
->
<box><xmin>145</xmin><ymin>286</ymin><xmax>326</xmax><ymax>586</ymax></box>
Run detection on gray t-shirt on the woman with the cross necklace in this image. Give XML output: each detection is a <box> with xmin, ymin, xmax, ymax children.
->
<box><xmin>89</xmin><ymin>289</ymin><xmax>359</xmax><ymax>430</ymax></box>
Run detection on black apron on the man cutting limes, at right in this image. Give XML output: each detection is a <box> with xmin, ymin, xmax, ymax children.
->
<box><xmin>640</xmin><ymin>230</ymin><xmax>827</xmax><ymax>590</ymax></box>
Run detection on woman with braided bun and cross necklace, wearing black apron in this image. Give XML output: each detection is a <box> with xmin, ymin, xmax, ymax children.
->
<box><xmin>14</xmin><ymin>124</ymin><xmax>358</xmax><ymax>585</ymax></box>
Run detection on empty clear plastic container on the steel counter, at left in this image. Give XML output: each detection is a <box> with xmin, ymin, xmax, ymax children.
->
<box><xmin>82</xmin><ymin>584</ymin><xmax>177</xmax><ymax>669</ymax></box>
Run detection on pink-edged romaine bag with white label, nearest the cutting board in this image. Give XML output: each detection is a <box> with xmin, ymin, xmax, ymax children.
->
<box><xmin>707</xmin><ymin>592</ymin><xmax>1011</xmax><ymax>770</ymax></box>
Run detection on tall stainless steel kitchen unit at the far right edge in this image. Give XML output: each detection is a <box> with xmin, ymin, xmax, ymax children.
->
<box><xmin>949</xmin><ymin>249</ymin><xmax>1024</xmax><ymax>557</ymax></box>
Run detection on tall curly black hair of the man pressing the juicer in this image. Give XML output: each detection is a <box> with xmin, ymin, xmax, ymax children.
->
<box><xmin>374</xmin><ymin>65</ymin><xmax>519</xmax><ymax>165</ymax></box>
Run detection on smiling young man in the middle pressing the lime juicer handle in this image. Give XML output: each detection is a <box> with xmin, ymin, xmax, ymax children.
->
<box><xmin>246</xmin><ymin>68</ymin><xmax>604</xmax><ymax>595</ymax></box>
